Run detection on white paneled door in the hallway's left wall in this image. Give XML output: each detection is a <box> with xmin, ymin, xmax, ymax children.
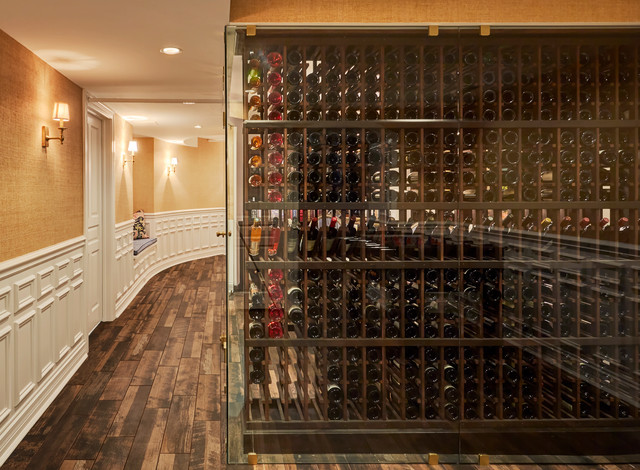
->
<box><xmin>86</xmin><ymin>115</ymin><xmax>103</xmax><ymax>332</ymax></box>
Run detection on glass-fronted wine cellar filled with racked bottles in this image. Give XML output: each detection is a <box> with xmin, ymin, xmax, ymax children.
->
<box><xmin>233</xmin><ymin>29</ymin><xmax>640</xmax><ymax>462</ymax></box>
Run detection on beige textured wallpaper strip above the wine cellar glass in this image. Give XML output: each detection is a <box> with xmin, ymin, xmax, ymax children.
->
<box><xmin>229</xmin><ymin>0</ymin><xmax>640</xmax><ymax>24</ymax></box>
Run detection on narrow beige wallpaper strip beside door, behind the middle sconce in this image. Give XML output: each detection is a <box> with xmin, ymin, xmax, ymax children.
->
<box><xmin>113</xmin><ymin>114</ymin><xmax>133</xmax><ymax>224</ymax></box>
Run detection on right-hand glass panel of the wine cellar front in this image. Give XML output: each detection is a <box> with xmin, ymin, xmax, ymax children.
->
<box><xmin>461</xmin><ymin>30</ymin><xmax>640</xmax><ymax>463</ymax></box>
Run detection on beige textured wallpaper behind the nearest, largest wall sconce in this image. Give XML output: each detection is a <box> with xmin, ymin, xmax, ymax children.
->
<box><xmin>0</xmin><ymin>31</ymin><xmax>84</xmax><ymax>261</ymax></box>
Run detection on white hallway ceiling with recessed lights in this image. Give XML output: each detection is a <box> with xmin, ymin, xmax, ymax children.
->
<box><xmin>0</xmin><ymin>0</ymin><xmax>230</xmax><ymax>145</ymax></box>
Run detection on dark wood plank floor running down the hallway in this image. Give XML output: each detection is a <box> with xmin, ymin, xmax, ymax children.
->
<box><xmin>2</xmin><ymin>256</ymin><xmax>635</xmax><ymax>470</ymax></box>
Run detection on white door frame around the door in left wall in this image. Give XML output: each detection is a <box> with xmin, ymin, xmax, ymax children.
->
<box><xmin>83</xmin><ymin>93</ymin><xmax>115</xmax><ymax>326</ymax></box>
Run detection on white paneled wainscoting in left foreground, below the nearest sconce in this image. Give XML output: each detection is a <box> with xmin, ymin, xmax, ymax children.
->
<box><xmin>0</xmin><ymin>237</ymin><xmax>88</xmax><ymax>465</ymax></box>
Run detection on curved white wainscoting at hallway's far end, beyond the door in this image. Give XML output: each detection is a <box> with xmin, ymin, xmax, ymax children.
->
<box><xmin>114</xmin><ymin>208</ymin><xmax>226</xmax><ymax>318</ymax></box>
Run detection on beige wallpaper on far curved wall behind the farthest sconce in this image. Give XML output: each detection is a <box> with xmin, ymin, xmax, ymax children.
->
<box><xmin>154</xmin><ymin>139</ymin><xmax>225</xmax><ymax>212</ymax></box>
